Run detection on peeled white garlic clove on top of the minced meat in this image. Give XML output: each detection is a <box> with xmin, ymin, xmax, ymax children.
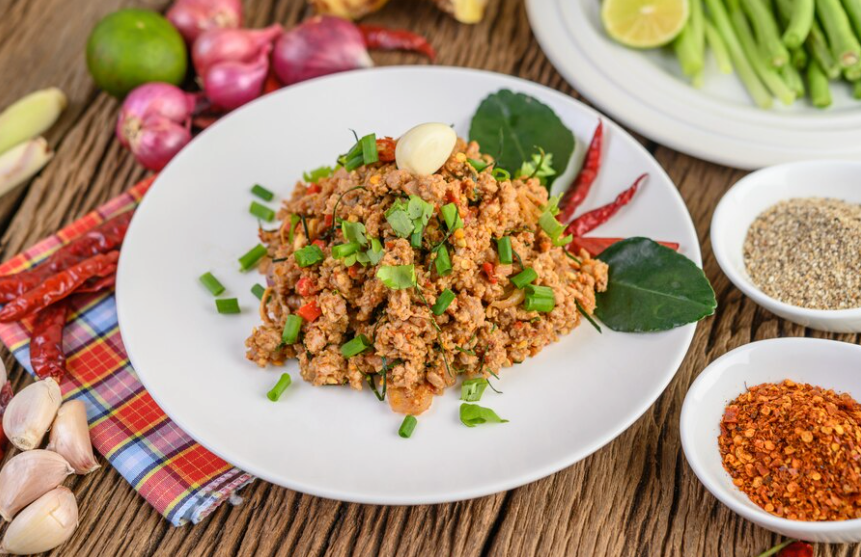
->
<box><xmin>395</xmin><ymin>122</ymin><xmax>457</xmax><ymax>176</ymax></box>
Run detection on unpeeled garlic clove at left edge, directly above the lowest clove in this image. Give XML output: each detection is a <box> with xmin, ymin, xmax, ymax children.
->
<box><xmin>0</xmin><ymin>449</ymin><xmax>74</xmax><ymax>520</ymax></box>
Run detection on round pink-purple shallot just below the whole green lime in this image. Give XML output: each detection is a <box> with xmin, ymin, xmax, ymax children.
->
<box><xmin>116</xmin><ymin>83</ymin><xmax>196</xmax><ymax>170</ymax></box>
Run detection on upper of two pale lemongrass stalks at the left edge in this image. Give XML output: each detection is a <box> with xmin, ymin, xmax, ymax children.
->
<box><xmin>0</xmin><ymin>87</ymin><xmax>68</xmax><ymax>155</ymax></box>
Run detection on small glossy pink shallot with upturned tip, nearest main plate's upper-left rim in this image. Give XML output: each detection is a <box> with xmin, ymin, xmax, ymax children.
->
<box><xmin>203</xmin><ymin>45</ymin><xmax>272</xmax><ymax>110</ymax></box>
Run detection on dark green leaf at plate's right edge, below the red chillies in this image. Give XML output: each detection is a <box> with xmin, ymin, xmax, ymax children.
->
<box><xmin>595</xmin><ymin>238</ymin><xmax>717</xmax><ymax>333</ymax></box>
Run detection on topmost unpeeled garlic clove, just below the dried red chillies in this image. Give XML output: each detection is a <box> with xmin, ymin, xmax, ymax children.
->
<box><xmin>3</xmin><ymin>377</ymin><xmax>63</xmax><ymax>451</ymax></box>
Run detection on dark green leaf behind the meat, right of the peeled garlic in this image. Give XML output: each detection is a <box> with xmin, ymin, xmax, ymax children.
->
<box><xmin>469</xmin><ymin>89</ymin><xmax>574</xmax><ymax>190</ymax></box>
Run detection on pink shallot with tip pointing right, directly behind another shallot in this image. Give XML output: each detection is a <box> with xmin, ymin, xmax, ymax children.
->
<box><xmin>191</xmin><ymin>23</ymin><xmax>283</xmax><ymax>76</ymax></box>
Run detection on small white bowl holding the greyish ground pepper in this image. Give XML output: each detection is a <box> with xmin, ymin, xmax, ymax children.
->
<box><xmin>711</xmin><ymin>161</ymin><xmax>861</xmax><ymax>333</ymax></box>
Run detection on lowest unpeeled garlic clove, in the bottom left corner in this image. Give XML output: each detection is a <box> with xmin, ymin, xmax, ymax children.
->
<box><xmin>0</xmin><ymin>486</ymin><xmax>78</xmax><ymax>555</ymax></box>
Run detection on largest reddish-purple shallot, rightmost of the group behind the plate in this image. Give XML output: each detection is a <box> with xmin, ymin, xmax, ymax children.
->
<box><xmin>272</xmin><ymin>16</ymin><xmax>374</xmax><ymax>85</ymax></box>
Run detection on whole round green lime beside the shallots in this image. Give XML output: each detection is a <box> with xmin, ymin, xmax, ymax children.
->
<box><xmin>87</xmin><ymin>9</ymin><xmax>188</xmax><ymax>98</ymax></box>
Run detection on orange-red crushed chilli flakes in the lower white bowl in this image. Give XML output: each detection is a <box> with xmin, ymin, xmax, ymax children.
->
<box><xmin>718</xmin><ymin>379</ymin><xmax>861</xmax><ymax>521</ymax></box>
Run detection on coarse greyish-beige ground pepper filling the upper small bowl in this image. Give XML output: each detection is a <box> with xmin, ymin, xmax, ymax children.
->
<box><xmin>744</xmin><ymin>197</ymin><xmax>861</xmax><ymax>309</ymax></box>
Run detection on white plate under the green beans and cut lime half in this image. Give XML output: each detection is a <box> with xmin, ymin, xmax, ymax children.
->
<box><xmin>526</xmin><ymin>0</ymin><xmax>861</xmax><ymax>169</ymax></box>
